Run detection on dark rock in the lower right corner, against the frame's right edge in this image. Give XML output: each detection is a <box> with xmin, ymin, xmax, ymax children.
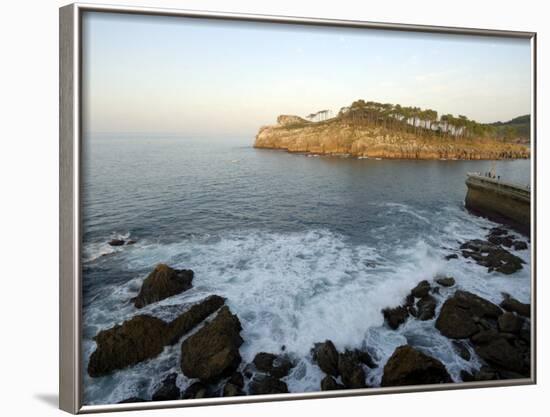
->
<box><xmin>475</xmin><ymin>338</ymin><xmax>529</xmax><ymax>375</ymax></box>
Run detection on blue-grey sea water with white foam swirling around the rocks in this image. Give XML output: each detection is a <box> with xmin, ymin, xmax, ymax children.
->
<box><xmin>83</xmin><ymin>136</ymin><xmax>530</xmax><ymax>404</ymax></box>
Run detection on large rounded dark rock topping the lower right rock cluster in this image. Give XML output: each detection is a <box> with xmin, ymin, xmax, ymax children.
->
<box><xmin>435</xmin><ymin>290</ymin><xmax>502</xmax><ymax>339</ymax></box>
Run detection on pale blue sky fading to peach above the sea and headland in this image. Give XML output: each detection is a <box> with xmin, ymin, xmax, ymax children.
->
<box><xmin>82</xmin><ymin>12</ymin><xmax>531</xmax><ymax>136</ymax></box>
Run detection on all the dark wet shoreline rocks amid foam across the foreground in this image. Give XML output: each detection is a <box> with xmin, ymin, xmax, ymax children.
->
<box><xmin>87</xmin><ymin>227</ymin><xmax>531</xmax><ymax>403</ymax></box>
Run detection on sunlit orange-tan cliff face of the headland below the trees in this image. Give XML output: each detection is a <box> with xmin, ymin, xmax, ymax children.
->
<box><xmin>254</xmin><ymin>115</ymin><xmax>530</xmax><ymax>159</ymax></box>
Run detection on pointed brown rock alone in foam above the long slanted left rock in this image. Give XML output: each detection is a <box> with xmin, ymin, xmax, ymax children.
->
<box><xmin>132</xmin><ymin>264</ymin><xmax>193</xmax><ymax>308</ymax></box>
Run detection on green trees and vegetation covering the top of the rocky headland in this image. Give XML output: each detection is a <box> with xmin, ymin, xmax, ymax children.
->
<box><xmin>306</xmin><ymin>100</ymin><xmax>530</xmax><ymax>142</ymax></box>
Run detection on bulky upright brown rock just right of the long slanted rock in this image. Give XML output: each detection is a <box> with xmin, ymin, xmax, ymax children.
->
<box><xmin>181</xmin><ymin>307</ymin><xmax>243</xmax><ymax>381</ymax></box>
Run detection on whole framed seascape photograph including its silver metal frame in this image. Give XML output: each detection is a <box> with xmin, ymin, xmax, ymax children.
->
<box><xmin>60</xmin><ymin>4</ymin><xmax>536</xmax><ymax>413</ymax></box>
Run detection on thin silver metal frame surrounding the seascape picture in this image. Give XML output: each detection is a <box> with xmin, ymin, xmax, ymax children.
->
<box><xmin>59</xmin><ymin>3</ymin><xmax>537</xmax><ymax>414</ymax></box>
